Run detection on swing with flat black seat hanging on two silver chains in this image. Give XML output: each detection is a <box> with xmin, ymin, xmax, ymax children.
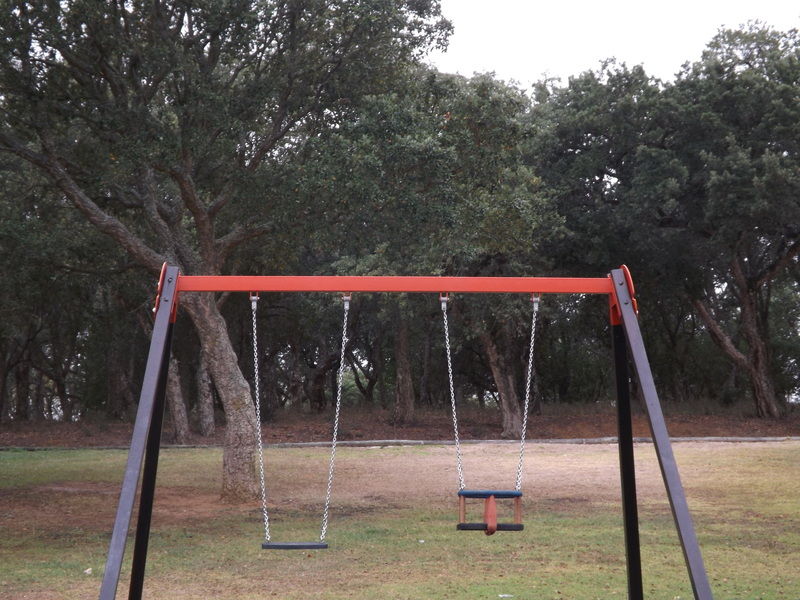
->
<box><xmin>250</xmin><ymin>294</ymin><xmax>350</xmax><ymax>550</ymax></box>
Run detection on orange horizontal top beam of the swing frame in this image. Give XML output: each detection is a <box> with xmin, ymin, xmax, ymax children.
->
<box><xmin>177</xmin><ymin>275</ymin><xmax>613</xmax><ymax>294</ymax></box>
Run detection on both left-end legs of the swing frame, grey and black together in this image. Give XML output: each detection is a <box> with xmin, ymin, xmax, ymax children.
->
<box><xmin>100</xmin><ymin>267</ymin><xmax>178</xmax><ymax>600</ymax></box>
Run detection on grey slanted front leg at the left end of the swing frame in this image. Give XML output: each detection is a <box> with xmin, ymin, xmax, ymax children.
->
<box><xmin>100</xmin><ymin>267</ymin><xmax>178</xmax><ymax>600</ymax></box>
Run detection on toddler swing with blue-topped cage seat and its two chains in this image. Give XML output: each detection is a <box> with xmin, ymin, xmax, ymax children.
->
<box><xmin>439</xmin><ymin>294</ymin><xmax>539</xmax><ymax>535</ymax></box>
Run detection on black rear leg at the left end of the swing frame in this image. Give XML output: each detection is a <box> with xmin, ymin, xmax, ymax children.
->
<box><xmin>128</xmin><ymin>323</ymin><xmax>173</xmax><ymax>600</ymax></box>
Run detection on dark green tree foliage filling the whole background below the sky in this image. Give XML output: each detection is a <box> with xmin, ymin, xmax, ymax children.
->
<box><xmin>0</xmin><ymin>15</ymin><xmax>800</xmax><ymax>426</ymax></box>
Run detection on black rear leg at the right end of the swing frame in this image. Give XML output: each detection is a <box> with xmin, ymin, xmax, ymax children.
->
<box><xmin>611</xmin><ymin>325</ymin><xmax>644</xmax><ymax>600</ymax></box>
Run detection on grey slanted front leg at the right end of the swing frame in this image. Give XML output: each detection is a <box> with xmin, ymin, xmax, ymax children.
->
<box><xmin>611</xmin><ymin>269</ymin><xmax>713</xmax><ymax>600</ymax></box>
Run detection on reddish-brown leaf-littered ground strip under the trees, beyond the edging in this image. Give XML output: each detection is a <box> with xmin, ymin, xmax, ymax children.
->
<box><xmin>0</xmin><ymin>407</ymin><xmax>800</xmax><ymax>448</ymax></box>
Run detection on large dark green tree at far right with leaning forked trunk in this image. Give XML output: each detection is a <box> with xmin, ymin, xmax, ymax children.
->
<box><xmin>533</xmin><ymin>25</ymin><xmax>800</xmax><ymax>417</ymax></box>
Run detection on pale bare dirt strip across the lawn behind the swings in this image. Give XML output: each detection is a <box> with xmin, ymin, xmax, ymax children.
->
<box><xmin>9</xmin><ymin>442</ymin><xmax>800</xmax><ymax>536</ymax></box>
